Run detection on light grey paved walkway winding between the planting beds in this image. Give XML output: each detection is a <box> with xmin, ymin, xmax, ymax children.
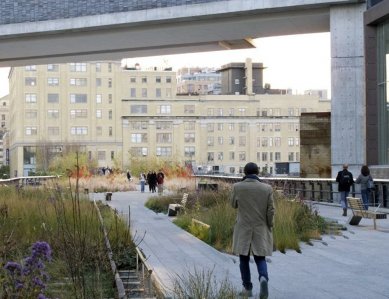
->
<box><xmin>90</xmin><ymin>191</ymin><xmax>389</xmax><ymax>299</ymax></box>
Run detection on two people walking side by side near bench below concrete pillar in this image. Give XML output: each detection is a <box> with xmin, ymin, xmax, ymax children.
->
<box><xmin>336</xmin><ymin>164</ymin><xmax>374</xmax><ymax>216</ymax></box>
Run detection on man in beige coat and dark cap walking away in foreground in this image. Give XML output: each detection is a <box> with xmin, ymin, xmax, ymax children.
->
<box><xmin>231</xmin><ymin>162</ymin><xmax>274</xmax><ymax>299</ymax></box>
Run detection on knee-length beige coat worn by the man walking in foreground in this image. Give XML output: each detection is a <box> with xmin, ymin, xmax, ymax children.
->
<box><xmin>230</xmin><ymin>178</ymin><xmax>274</xmax><ymax>256</ymax></box>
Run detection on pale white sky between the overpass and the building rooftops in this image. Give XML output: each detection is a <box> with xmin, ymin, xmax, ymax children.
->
<box><xmin>0</xmin><ymin>33</ymin><xmax>331</xmax><ymax>97</ymax></box>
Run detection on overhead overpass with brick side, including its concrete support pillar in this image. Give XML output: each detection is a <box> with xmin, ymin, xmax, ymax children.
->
<box><xmin>0</xmin><ymin>0</ymin><xmax>366</xmax><ymax>174</ymax></box>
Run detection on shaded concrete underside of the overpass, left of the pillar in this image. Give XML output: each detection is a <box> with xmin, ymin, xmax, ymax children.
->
<box><xmin>0</xmin><ymin>8</ymin><xmax>329</xmax><ymax>66</ymax></box>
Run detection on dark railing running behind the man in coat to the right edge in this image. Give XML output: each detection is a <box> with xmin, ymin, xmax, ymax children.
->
<box><xmin>196</xmin><ymin>175</ymin><xmax>389</xmax><ymax>208</ymax></box>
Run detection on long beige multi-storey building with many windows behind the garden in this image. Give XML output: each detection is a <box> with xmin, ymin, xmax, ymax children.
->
<box><xmin>9</xmin><ymin>62</ymin><xmax>330</xmax><ymax>176</ymax></box>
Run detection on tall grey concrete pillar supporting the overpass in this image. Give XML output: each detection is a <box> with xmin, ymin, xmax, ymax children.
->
<box><xmin>330</xmin><ymin>3</ymin><xmax>366</xmax><ymax>177</ymax></box>
